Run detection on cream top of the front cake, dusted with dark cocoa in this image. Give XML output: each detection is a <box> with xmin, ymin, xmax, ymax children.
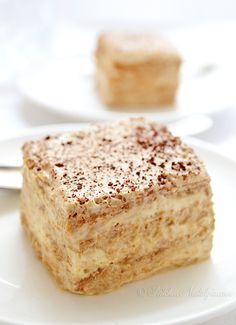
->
<box><xmin>23</xmin><ymin>118</ymin><xmax>204</xmax><ymax>204</ymax></box>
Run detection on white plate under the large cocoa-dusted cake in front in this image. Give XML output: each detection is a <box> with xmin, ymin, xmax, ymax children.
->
<box><xmin>0</xmin><ymin>127</ymin><xmax>236</xmax><ymax>325</ymax></box>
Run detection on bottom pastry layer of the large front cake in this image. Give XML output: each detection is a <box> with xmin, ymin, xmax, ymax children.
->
<box><xmin>22</xmin><ymin>215</ymin><xmax>212</xmax><ymax>295</ymax></box>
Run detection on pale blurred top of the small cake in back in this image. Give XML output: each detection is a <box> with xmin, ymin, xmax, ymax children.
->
<box><xmin>97</xmin><ymin>32</ymin><xmax>181</xmax><ymax>64</ymax></box>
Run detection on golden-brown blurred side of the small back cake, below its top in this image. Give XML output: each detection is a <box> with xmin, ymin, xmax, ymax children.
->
<box><xmin>96</xmin><ymin>58</ymin><xmax>179</xmax><ymax>106</ymax></box>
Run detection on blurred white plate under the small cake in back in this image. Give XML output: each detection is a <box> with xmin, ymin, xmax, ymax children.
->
<box><xmin>19</xmin><ymin>29</ymin><xmax>236</xmax><ymax>122</ymax></box>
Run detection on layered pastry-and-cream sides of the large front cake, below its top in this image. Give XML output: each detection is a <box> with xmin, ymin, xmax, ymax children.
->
<box><xmin>21</xmin><ymin>162</ymin><xmax>214</xmax><ymax>294</ymax></box>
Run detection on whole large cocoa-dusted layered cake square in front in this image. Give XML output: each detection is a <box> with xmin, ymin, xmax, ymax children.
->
<box><xmin>21</xmin><ymin>118</ymin><xmax>214</xmax><ymax>295</ymax></box>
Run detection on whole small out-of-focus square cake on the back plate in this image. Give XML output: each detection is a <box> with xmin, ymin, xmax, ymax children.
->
<box><xmin>95</xmin><ymin>32</ymin><xmax>181</xmax><ymax>107</ymax></box>
